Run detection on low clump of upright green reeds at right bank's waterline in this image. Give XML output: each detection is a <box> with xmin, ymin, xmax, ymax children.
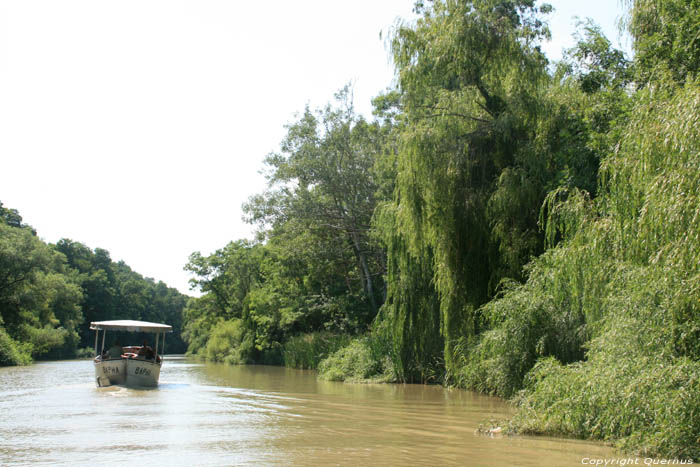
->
<box><xmin>282</xmin><ymin>332</ymin><xmax>350</xmax><ymax>370</ymax></box>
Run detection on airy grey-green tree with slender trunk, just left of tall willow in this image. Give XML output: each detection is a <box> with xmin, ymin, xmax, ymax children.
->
<box><xmin>244</xmin><ymin>87</ymin><xmax>383</xmax><ymax>322</ymax></box>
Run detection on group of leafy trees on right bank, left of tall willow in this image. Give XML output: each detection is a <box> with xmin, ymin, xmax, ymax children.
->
<box><xmin>184</xmin><ymin>87</ymin><xmax>397</xmax><ymax>367</ymax></box>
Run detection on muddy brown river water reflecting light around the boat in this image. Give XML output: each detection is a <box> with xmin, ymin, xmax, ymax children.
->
<box><xmin>0</xmin><ymin>357</ymin><xmax>618</xmax><ymax>467</ymax></box>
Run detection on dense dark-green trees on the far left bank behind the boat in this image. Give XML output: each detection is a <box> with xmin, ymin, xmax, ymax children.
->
<box><xmin>0</xmin><ymin>203</ymin><xmax>188</xmax><ymax>365</ymax></box>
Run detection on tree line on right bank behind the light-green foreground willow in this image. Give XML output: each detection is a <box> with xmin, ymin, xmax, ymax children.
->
<box><xmin>184</xmin><ymin>1</ymin><xmax>620</xmax><ymax>376</ymax></box>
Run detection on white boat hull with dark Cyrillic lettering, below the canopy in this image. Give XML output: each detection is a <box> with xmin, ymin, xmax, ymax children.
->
<box><xmin>95</xmin><ymin>358</ymin><xmax>161</xmax><ymax>387</ymax></box>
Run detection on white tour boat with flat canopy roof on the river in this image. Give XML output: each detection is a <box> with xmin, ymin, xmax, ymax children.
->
<box><xmin>90</xmin><ymin>320</ymin><xmax>173</xmax><ymax>387</ymax></box>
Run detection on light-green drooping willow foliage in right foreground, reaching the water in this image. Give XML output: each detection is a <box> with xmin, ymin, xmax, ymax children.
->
<box><xmin>462</xmin><ymin>75</ymin><xmax>700</xmax><ymax>459</ymax></box>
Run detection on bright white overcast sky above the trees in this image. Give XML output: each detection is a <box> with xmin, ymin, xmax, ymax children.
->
<box><xmin>0</xmin><ymin>0</ymin><xmax>622</xmax><ymax>294</ymax></box>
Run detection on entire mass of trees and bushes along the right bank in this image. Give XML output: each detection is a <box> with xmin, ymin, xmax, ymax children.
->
<box><xmin>184</xmin><ymin>0</ymin><xmax>700</xmax><ymax>459</ymax></box>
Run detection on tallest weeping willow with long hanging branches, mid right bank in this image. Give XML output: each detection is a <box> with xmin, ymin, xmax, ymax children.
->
<box><xmin>383</xmin><ymin>0</ymin><xmax>551</xmax><ymax>380</ymax></box>
